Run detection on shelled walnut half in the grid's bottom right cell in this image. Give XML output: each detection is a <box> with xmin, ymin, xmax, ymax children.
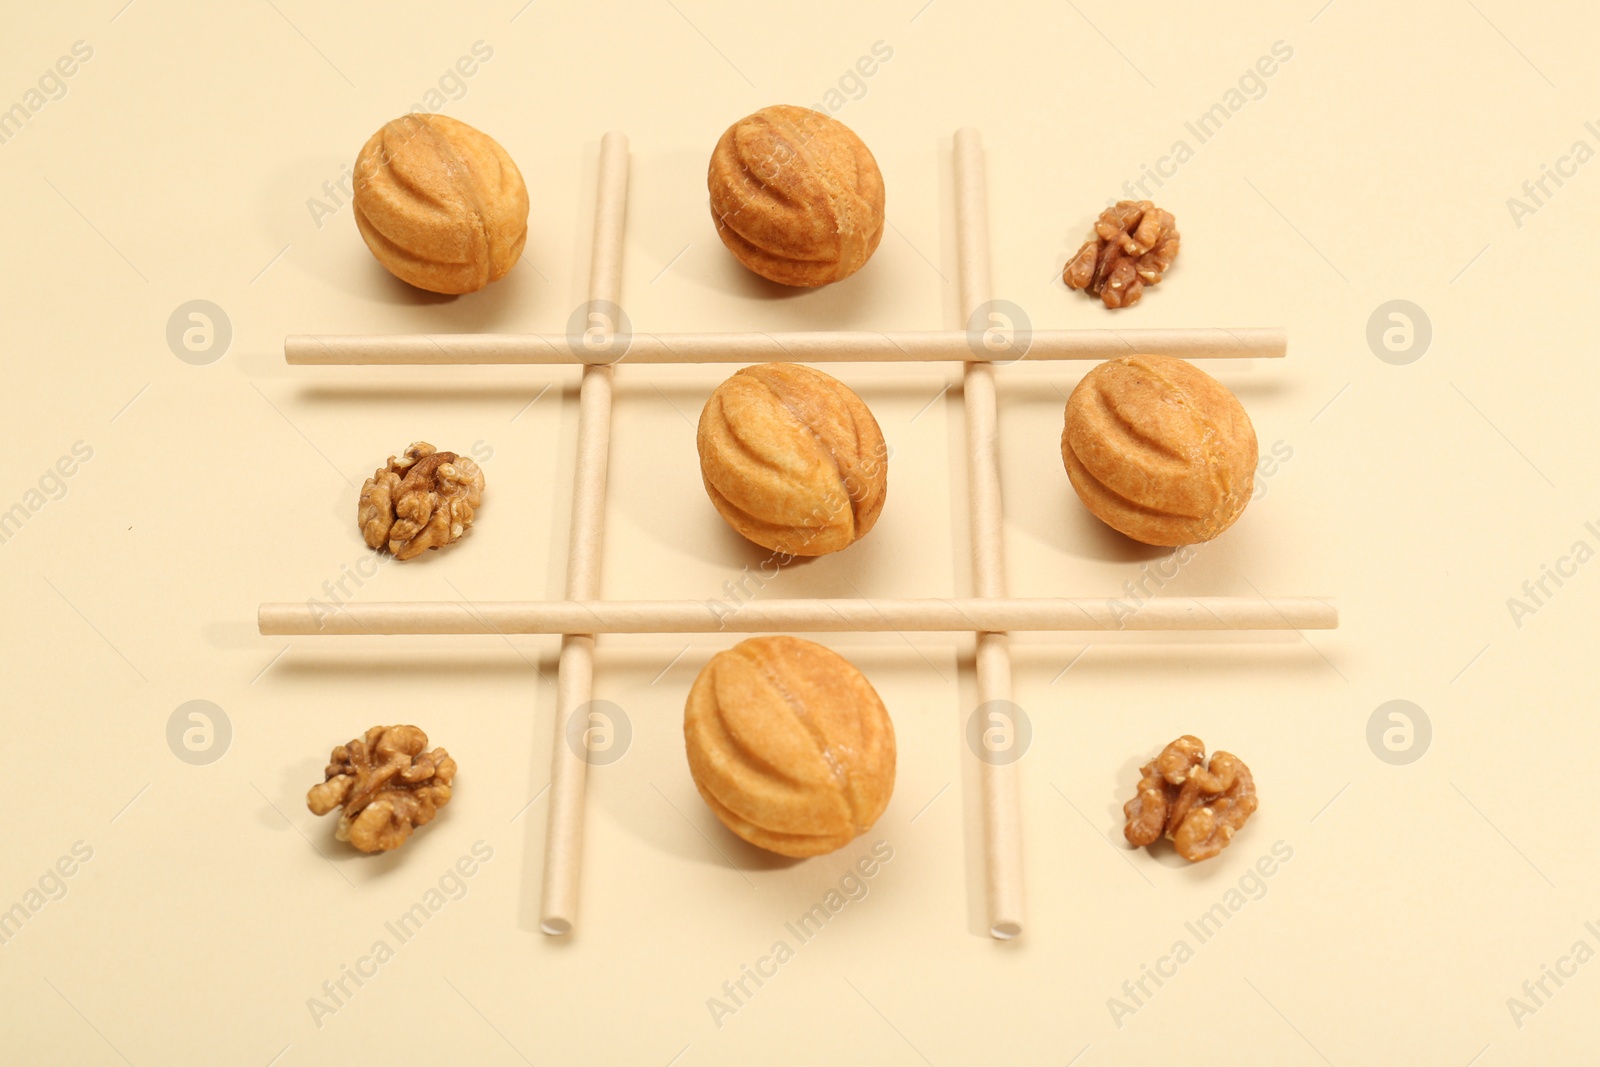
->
<box><xmin>1122</xmin><ymin>734</ymin><xmax>1256</xmax><ymax>862</ymax></box>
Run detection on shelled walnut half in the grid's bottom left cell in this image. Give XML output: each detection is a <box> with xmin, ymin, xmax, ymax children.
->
<box><xmin>306</xmin><ymin>726</ymin><xmax>456</xmax><ymax>853</ymax></box>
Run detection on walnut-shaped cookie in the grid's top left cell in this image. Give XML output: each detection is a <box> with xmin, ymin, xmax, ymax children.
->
<box><xmin>354</xmin><ymin>115</ymin><xmax>528</xmax><ymax>293</ymax></box>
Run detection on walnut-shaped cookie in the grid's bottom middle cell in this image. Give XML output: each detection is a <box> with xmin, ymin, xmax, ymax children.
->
<box><xmin>683</xmin><ymin>637</ymin><xmax>894</xmax><ymax>856</ymax></box>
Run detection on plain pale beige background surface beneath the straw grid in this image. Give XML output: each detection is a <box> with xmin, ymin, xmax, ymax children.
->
<box><xmin>0</xmin><ymin>0</ymin><xmax>1600</xmax><ymax>1067</ymax></box>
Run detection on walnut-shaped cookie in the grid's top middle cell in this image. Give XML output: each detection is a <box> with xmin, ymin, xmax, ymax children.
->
<box><xmin>706</xmin><ymin>104</ymin><xmax>883</xmax><ymax>286</ymax></box>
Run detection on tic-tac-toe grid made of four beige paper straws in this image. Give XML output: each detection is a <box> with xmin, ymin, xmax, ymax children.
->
<box><xmin>258</xmin><ymin>130</ymin><xmax>1338</xmax><ymax>939</ymax></box>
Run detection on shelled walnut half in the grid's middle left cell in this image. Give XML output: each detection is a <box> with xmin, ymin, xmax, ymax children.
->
<box><xmin>355</xmin><ymin>442</ymin><xmax>483</xmax><ymax>560</ymax></box>
